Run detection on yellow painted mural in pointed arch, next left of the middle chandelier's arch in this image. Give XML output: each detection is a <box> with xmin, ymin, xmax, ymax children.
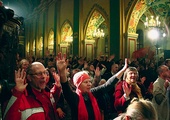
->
<box><xmin>61</xmin><ymin>21</ymin><xmax>73</xmax><ymax>42</ymax></box>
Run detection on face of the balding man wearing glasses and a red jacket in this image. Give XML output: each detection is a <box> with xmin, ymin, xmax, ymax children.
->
<box><xmin>29</xmin><ymin>64</ymin><xmax>47</xmax><ymax>91</ymax></box>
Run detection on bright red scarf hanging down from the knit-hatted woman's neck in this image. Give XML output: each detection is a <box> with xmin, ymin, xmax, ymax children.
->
<box><xmin>76</xmin><ymin>89</ymin><xmax>102</xmax><ymax>120</ymax></box>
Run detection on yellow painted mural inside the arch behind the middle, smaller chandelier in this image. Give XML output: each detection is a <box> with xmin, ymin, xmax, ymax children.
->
<box><xmin>86</xmin><ymin>10</ymin><xmax>105</xmax><ymax>40</ymax></box>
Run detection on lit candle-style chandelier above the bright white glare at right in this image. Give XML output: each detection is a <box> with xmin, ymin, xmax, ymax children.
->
<box><xmin>144</xmin><ymin>16</ymin><xmax>161</xmax><ymax>28</ymax></box>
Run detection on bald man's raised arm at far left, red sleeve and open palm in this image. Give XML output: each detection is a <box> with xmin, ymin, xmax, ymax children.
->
<box><xmin>3</xmin><ymin>69</ymin><xmax>27</xmax><ymax>120</ymax></box>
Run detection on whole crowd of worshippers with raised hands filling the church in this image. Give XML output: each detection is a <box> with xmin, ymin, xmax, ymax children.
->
<box><xmin>2</xmin><ymin>53</ymin><xmax>170</xmax><ymax>120</ymax></box>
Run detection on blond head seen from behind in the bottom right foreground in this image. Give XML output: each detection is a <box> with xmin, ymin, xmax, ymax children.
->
<box><xmin>117</xmin><ymin>99</ymin><xmax>158</xmax><ymax>120</ymax></box>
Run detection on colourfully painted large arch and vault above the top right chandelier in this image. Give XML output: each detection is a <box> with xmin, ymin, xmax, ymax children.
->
<box><xmin>128</xmin><ymin>0</ymin><xmax>170</xmax><ymax>33</ymax></box>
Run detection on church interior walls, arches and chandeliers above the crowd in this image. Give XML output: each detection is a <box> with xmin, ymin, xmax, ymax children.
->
<box><xmin>0</xmin><ymin>0</ymin><xmax>170</xmax><ymax>118</ymax></box>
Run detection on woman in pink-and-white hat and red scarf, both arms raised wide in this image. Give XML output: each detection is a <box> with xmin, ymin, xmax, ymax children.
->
<box><xmin>57</xmin><ymin>53</ymin><xmax>127</xmax><ymax>120</ymax></box>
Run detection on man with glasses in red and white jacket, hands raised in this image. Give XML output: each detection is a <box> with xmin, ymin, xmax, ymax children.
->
<box><xmin>3</xmin><ymin>62</ymin><xmax>61</xmax><ymax>120</ymax></box>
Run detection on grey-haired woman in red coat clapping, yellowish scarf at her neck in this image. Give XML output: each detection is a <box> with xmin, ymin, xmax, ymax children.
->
<box><xmin>114</xmin><ymin>67</ymin><xmax>143</xmax><ymax>113</ymax></box>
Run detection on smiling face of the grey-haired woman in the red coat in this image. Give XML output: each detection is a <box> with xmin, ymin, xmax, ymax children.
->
<box><xmin>126</xmin><ymin>71</ymin><xmax>138</xmax><ymax>85</ymax></box>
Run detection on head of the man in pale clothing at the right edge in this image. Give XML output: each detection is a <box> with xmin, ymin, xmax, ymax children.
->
<box><xmin>157</xmin><ymin>65</ymin><xmax>169</xmax><ymax>79</ymax></box>
